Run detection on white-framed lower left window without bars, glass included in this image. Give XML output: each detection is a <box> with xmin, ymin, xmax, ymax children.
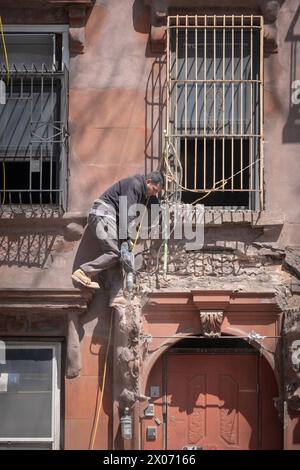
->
<box><xmin>0</xmin><ymin>340</ymin><xmax>60</xmax><ymax>449</ymax></box>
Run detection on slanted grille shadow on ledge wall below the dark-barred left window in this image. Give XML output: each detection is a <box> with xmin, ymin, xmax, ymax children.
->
<box><xmin>0</xmin><ymin>232</ymin><xmax>57</xmax><ymax>268</ymax></box>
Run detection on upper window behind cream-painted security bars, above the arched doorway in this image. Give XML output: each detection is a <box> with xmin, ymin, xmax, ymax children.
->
<box><xmin>165</xmin><ymin>15</ymin><xmax>263</xmax><ymax>210</ymax></box>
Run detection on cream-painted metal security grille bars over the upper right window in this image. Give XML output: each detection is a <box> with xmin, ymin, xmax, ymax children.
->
<box><xmin>163</xmin><ymin>14</ymin><xmax>264</xmax><ymax>212</ymax></box>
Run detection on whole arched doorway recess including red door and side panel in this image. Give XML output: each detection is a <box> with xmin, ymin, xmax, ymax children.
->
<box><xmin>141</xmin><ymin>338</ymin><xmax>282</xmax><ymax>450</ymax></box>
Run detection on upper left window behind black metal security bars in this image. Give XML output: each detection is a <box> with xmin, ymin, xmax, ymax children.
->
<box><xmin>0</xmin><ymin>33</ymin><xmax>68</xmax><ymax>208</ymax></box>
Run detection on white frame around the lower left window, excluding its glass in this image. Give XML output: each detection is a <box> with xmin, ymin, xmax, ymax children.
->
<box><xmin>0</xmin><ymin>339</ymin><xmax>61</xmax><ymax>450</ymax></box>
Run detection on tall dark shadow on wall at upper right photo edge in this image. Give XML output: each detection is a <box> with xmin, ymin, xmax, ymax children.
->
<box><xmin>282</xmin><ymin>6</ymin><xmax>300</xmax><ymax>144</ymax></box>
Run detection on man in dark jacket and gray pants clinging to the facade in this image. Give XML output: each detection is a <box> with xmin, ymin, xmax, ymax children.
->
<box><xmin>72</xmin><ymin>171</ymin><xmax>164</xmax><ymax>306</ymax></box>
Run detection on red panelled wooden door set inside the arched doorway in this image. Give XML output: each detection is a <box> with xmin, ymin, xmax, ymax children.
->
<box><xmin>166</xmin><ymin>354</ymin><xmax>275</xmax><ymax>450</ymax></box>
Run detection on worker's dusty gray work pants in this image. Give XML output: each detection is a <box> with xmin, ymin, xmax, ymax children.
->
<box><xmin>80</xmin><ymin>214</ymin><xmax>120</xmax><ymax>276</ymax></box>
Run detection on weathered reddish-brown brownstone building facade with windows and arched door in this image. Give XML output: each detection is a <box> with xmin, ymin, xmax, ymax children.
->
<box><xmin>0</xmin><ymin>0</ymin><xmax>300</xmax><ymax>450</ymax></box>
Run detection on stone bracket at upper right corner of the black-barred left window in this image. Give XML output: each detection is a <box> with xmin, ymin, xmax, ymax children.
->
<box><xmin>47</xmin><ymin>0</ymin><xmax>92</xmax><ymax>54</ymax></box>
